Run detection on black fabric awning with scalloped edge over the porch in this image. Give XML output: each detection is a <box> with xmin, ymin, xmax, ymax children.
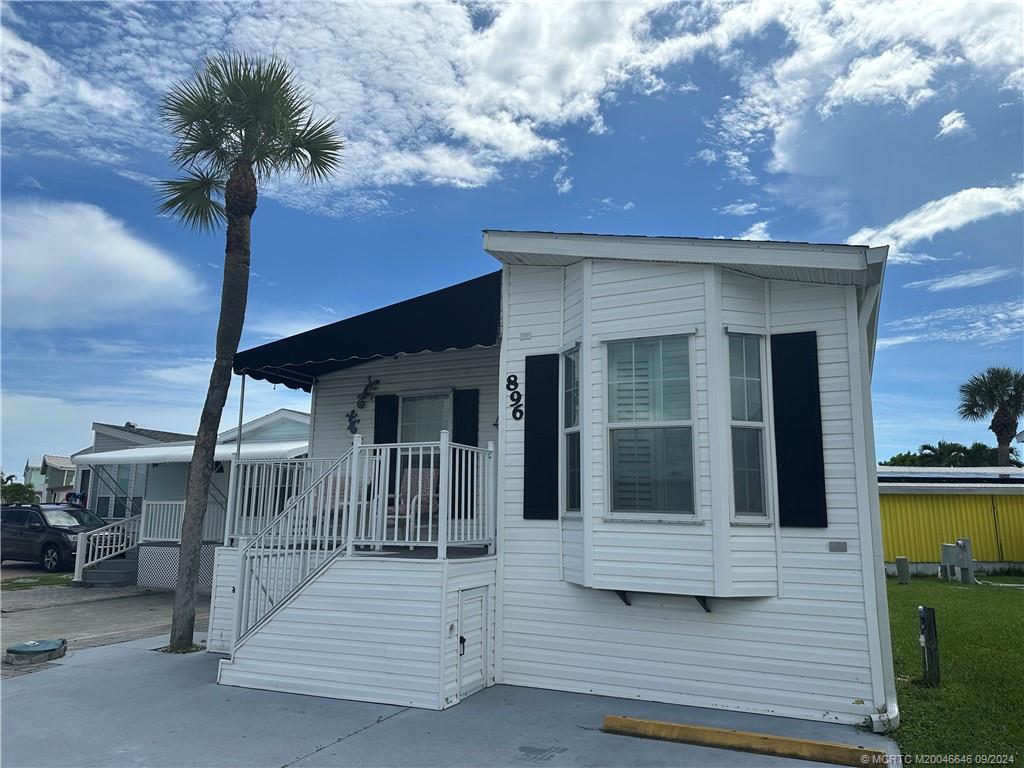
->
<box><xmin>234</xmin><ymin>271</ymin><xmax>502</xmax><ymax>392</ymax></box>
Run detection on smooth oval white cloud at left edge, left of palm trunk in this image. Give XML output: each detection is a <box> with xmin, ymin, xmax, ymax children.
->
<box><xmin>2</xmin><ymin>201</ymin><xmax>202</xmax><ymax>330</ymax></box>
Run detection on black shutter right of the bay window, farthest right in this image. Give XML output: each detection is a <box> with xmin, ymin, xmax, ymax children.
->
<box><xmin>771</xmin><ymin>331</ymin><xmax>828</xmax><ymax>528</ymax></box>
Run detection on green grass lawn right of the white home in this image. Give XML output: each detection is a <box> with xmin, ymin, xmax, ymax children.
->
<box><xmin>888</xmin><ymin>575</ymin><xmax>1024</xmax><ymax>766</ymax></box>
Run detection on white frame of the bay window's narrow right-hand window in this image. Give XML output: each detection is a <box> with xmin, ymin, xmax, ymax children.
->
<box><xmin>722</xmin><ymin>333</ymin><xmax>775</xmax><ymax>526</ymax></box>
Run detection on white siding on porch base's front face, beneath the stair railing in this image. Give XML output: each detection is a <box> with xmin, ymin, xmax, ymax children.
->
<box><xmin>218</xmin><ymin>557</ymin><xmax>444</xmax><ymax>709</ymax></box>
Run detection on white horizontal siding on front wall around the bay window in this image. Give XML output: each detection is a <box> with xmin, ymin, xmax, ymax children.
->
<box><xmin>499</xmin><ymin>261</ymin><xmax>881</xmax><ymax>723</ymax></box>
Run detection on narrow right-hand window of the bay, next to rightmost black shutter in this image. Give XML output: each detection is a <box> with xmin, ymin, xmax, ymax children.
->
<box><xmin>728</xmin><ymin>334</ymin><xmax>768</xmax><ymax>519</ymax></box>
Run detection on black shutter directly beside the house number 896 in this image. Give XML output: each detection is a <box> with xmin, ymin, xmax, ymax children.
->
<box><xmin>522</xmin><ymin>354</ymin><xmax>558</xmax><ymax>520</ymax></box>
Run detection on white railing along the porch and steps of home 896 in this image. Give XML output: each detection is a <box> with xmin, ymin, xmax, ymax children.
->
<box><xmin>235</xmin><ymin>432</ymin><xmax>497</xmax><ymax>643</ymax></box>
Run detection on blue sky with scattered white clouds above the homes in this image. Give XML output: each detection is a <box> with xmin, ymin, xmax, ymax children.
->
<box><xmin>0</xmin><ymin>2</ymin><xmax>1024</xmax><ymax>471</ymax></box>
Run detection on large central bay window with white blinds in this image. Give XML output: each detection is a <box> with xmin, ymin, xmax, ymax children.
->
<box><xmin>608</xmin><ymin>336</ymin><xmax>694</xmax><ymax>514</ymax></box>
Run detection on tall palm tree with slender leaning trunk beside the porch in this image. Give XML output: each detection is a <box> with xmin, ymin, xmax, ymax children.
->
<box><xmin>159</xmin><ymin>53</ymin><xmax>345</xmax><ymax>650</ymax></box>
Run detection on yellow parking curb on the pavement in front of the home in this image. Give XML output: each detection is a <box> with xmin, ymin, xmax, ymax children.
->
<box><xmin>601</xmin><ymin>715</ymin><xmax>886</xmax><ymax>766</ymax></box>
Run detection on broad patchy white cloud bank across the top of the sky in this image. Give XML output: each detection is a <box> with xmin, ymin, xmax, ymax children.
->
<box><xmin>3</xmin><ymin>0</ymin><xmax>1022</xmax><ymax>216</ymax></box>
